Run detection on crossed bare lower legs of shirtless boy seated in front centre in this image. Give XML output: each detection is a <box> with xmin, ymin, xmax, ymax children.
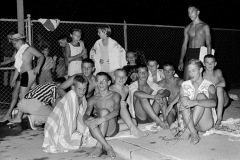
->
<box><xmin>90</xmin><ymin>109</ymin><xmax>116</xmax><ymax>158</ymax></box>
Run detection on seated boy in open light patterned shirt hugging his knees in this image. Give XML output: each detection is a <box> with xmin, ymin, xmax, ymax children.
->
<box><xmin>180</xmin><ymin>59</ymin><xmax>217</xmax><ymax>144</ymax></box>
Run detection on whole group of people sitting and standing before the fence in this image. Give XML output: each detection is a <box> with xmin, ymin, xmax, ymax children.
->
<box><xmin>0</xmin><ymin>3</ymin><xmax>229</xmax><ymax>158</ymax></box>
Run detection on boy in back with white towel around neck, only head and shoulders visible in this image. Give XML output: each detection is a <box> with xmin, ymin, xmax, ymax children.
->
<box><xmin>148</xmin><ymin>59</ymin><xmax>178</xmax><ymax>83</ymax></box>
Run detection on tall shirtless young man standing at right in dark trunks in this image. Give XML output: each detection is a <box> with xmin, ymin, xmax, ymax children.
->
<box><xmin>178</xmin><ymin>6</ymin><xmax>212</xmax><ymax>80</ymax></box>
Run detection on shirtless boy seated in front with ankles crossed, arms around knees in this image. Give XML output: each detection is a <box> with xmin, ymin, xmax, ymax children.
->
<box><xmin>83</xmin><ymin>72</ymin><xmax>121</xmax><ymax>158</ymax></box>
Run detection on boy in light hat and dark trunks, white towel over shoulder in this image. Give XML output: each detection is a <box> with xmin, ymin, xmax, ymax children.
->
<box><xmin>11</xmin><ymin>33</ymin><xmax>44</xmax><ymax>117</ymax></box>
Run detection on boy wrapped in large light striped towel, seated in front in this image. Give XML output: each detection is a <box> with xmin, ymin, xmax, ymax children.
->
<box><xmin>42</xmin><ymin>75</ymin><xmax>88</xmax><ymax>153</ymax></box>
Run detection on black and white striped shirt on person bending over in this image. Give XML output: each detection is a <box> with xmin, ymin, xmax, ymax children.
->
<box><xmin>24</xmin><ymin>83</ymin><xmax>57</xmax><ymax>105</ymax></box>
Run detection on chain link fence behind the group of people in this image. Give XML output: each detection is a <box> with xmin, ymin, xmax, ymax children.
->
<box><xmin>0</xmin><ymin>19</ymin><xmax>240</xmax><ymax>115</ymax></box>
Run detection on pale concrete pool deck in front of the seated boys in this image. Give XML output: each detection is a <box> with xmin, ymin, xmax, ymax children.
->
<box><xmin>0</xmin><ymin>90</ymin><xmax>240</xmax><ymax>160</ymax></box>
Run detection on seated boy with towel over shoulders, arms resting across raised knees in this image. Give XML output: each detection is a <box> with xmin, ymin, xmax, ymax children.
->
<box><xmin>129</xmin><ymin>66</ymin><xmax>170</xmax><ymax>129</ymax></box>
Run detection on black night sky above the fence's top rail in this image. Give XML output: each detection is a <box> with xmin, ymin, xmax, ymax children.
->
<box><xmin>0</xmin><ymin>0</ymin><xmax>240</xmax><ymax>29</ymax></box>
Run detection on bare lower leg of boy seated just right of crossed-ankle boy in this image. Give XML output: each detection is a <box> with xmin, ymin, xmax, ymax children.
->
<box><xmin>120</xmin><ymin>107</ymin><xmax>147</xmax><ymax>137</ymax></box>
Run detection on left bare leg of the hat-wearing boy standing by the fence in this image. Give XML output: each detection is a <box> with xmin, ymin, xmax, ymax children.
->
<box><xmin>0</xmin><ymin>81</ymin><xmax>20</xmax><ymax>122</ymax></box>
